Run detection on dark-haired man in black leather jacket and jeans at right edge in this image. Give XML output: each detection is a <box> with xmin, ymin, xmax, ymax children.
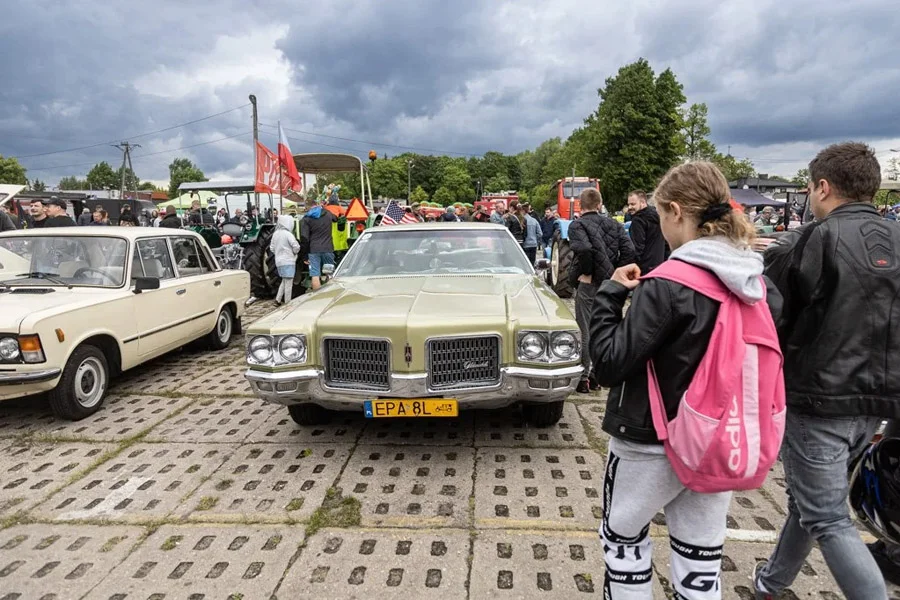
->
<box><xmin>754</xmin><ymin>143</ymin><xmax>900</xmax><ymax>599</ymax></box>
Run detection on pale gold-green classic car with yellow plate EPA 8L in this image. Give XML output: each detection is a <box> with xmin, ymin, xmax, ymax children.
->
<box><xmin>247</xmin><ymin>223</ymin><xmax>582</xmax><ymax>426</ymax></box>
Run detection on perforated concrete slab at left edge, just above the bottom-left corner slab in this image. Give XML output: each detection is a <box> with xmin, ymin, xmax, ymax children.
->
<box><xmin>0</xmin><ymin>442</ymin><xmax>115</xmax><ymax>516</ymax></box>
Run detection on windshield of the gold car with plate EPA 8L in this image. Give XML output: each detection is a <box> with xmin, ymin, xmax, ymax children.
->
<box><xmin>335</xmin><ymin>228</ymin><xmax>534</xmax><ymax>277</ymax></box>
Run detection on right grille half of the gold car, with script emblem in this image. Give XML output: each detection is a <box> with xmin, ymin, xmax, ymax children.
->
<box><xmin>428</xmin><ymin>336</ymin><xmax>500</xmax><ymax>390</ymax></box>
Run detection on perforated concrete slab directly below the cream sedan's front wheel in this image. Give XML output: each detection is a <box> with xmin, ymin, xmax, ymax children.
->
<box><xmin>37</xmin><ymin>395</ymin><xmax>193</xmax><ymax>441</ymax></box>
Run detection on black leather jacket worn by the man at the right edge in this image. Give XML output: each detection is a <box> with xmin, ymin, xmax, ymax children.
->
<box><xmin>765</xmin><ymin>202</ymin><xmax>900</xmax><ymax>419</ymax></box>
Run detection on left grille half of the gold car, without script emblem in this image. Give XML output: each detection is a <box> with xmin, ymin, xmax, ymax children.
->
<box><xmin>325</xmin><ymin>338</ymin><xmax>391</xmax><ymax>390</ymax></box>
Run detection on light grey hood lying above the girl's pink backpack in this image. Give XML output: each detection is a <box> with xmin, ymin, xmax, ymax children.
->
<box><xmin>671</xmin><ymin>236</ymin><xmax>764</xmax><ymax>304</ymax></box>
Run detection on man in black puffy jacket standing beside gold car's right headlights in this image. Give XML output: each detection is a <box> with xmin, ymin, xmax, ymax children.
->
<box><xmin>569</xmin><ymin>188</ymin><xmax>635</xmax><ymax>394</ymax></box>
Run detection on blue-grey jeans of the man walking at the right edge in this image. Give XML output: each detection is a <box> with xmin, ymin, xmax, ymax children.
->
<box><xmin>758</xmin><ymin>408</ymin><xmax>887</xmax><ymax>600</ymax></box>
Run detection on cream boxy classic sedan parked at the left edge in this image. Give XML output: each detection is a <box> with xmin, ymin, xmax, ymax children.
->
<box><xmin>0</xmin><ymin>227</ymin><xmax>250</xmax><ymax>420</ymax></box>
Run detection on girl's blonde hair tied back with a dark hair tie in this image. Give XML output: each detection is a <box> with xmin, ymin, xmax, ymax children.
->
<box><xmin>653</xmin><ymin>162</ymin><xmax>756</xmax><ymax>246</ymax></box>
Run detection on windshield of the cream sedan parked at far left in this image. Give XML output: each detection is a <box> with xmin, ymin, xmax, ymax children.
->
<box><xmin>0</xmin><ymin>234</ymin><xmax>128</xmax><ymax>287</ymax></box>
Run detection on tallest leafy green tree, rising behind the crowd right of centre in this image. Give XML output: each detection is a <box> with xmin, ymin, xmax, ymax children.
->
<box><xmin>585</xmin><ymin>58</ymin><xmax>685</xmax><ymax>210</ymax></box>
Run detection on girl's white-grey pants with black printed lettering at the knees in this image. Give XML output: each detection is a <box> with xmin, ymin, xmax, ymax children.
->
<box><xmin>600</xmin><ymin>438</ymin><xmax>731</xmax><ymax>600</ymax></box>
